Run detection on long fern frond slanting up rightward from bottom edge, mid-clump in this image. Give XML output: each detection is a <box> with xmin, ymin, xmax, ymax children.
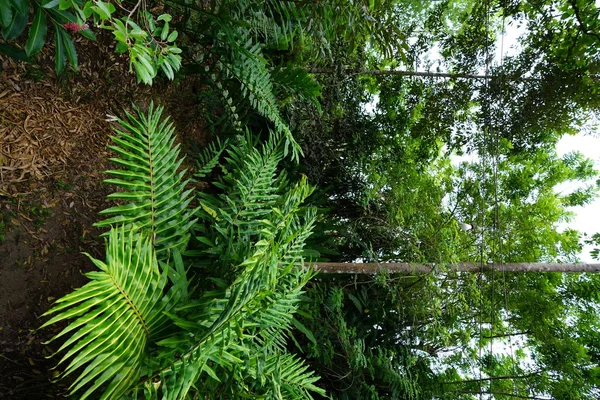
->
<box><xmin>155</xmin><ymin>223</ymin><xmax>316</xmax><ymax>399</ymax></box>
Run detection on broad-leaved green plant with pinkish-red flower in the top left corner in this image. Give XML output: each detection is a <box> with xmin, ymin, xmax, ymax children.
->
<box><xmin>0</xmin><ymin>0</ymin><xmax>182</xmax><ymax>85</ymax></box>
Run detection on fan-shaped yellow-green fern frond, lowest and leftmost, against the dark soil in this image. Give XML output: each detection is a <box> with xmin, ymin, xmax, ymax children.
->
<box><xmin>42</xmin><ymin>228</ymin><xmax>174</xmax><ymax>399</ymax></box>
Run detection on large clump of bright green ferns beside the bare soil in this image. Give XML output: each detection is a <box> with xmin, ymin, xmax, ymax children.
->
<box><xmin>43</xmin><ymin>106</ymin><xmax>325</xmax><ymax>399</ymax></box>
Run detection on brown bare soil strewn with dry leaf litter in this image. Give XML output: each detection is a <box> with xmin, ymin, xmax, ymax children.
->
<box><xmin>0</xmin><ymin>30</ymin><xmax>207</xmax><ymax>399</ymax></box>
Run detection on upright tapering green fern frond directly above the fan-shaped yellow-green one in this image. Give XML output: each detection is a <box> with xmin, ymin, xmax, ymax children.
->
<box><xmin>95</xmin><ymin>105</ymin><xmax>195</xmax><ymax>258</ymax></box>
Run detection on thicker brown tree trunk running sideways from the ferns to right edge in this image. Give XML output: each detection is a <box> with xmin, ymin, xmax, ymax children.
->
<box><xmin>307</xmin><ymin>262</ymin><xmax>600</xmax><ymax>274</ymax></box>
